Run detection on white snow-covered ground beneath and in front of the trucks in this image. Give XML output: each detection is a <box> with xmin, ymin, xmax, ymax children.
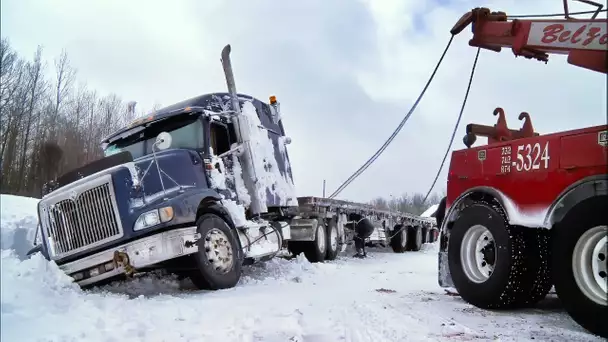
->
<box><xmin>1</xmin><ymin>196</ymin><xmax>601</xmax><ymax>342</ymax></box>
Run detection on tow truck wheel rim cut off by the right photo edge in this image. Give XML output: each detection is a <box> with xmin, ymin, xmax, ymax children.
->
<box><xmin>572</xmin><ymin>226</ymin><xmax>608</xmax><ymax>306</ymax></box>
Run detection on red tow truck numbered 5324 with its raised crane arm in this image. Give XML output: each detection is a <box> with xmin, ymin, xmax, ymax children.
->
<box><xmin>437</xmin><ymin>0</ymin><xmax>608</xmax><ymax>337</ymax></box>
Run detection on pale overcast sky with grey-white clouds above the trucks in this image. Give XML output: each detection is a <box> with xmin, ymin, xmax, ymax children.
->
<box><xmin>1</xmin><ymin>0</ymin><xmax>606</xmax><ymax>201</ymax></box>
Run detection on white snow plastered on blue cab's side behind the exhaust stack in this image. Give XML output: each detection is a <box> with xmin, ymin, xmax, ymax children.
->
<box><xmin>242</xmin><ymin>101</ymin><xmax>298</xmax><ymax>206</ymax></box>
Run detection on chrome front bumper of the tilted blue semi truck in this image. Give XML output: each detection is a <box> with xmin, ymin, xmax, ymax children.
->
<box><xmin>59</xmin><ymin>227</ymin><xmax>200</xmax><ymax>286</ymax></box>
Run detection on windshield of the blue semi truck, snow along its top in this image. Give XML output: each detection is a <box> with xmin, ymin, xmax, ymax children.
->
<box><xmin>104</xmin><ymin>115</ymin><xmax>204</xmax><ymax>159</ymax></box>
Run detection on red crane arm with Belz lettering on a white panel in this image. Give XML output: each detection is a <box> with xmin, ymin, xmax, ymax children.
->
<box><xmin>450</xmin><ymin>8</ymin><xmax>608</xmax><ymax>73</ymax></box>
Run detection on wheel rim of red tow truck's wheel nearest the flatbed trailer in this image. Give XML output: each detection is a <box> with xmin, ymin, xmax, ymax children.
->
<box><xmin>460</xmin><ymin>225</ymin><xmax>496</xmax><ymax>284</ymax></box>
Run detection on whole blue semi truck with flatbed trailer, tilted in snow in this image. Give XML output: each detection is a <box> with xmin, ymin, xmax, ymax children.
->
<box><xmin>31</xmin><ymin>45</ymin><xmax>437</xmax><ymax>290</ymax></box>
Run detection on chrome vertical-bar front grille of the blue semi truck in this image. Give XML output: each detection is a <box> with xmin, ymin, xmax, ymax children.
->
<box><xmin>44</xmin><ymin>176</ymin><xmax>123</xmax><ymax>259</ymax></box>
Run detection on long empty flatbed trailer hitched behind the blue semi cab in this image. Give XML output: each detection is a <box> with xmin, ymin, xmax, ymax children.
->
<box><xmin>288</xmin><ymin>197</ymin><xmax>439</xmax><ymax>262</ymax></box>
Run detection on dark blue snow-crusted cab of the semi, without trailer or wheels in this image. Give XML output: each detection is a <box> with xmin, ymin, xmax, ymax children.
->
<box><xmin>33</xmin><ymin>93</ymin><xmax>297</xmax><ymax>286</ymax></box>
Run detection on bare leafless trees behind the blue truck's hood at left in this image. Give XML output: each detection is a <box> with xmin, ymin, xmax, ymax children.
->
<box><xmin>0</xmin><ymin>37</ymin><xmax>147</xmax><ymax>197</ymax></box>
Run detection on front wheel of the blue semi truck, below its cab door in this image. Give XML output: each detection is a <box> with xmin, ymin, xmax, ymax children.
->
<box><xmin>190</xmin><ymin>214</ymin><xmax>242</xmax><ymax>290</ymax></box>
